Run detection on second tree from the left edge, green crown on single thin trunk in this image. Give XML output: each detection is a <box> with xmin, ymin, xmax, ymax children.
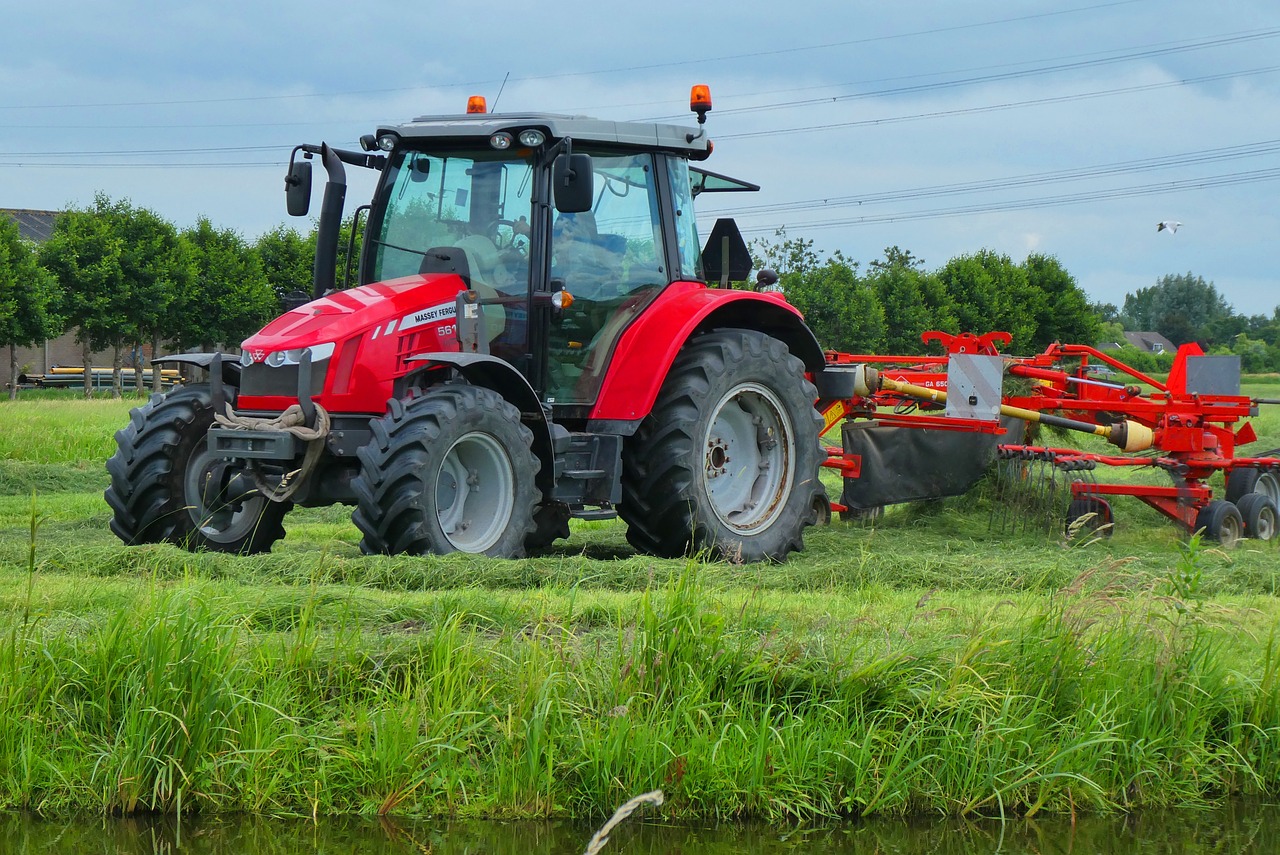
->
<box><xmin>40</xmin><ymin>195</ymin><xmax>129</xmax><ymax>398</ymax></box>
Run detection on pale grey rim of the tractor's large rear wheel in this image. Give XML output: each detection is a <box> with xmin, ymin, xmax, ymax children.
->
<box><xmin>703</xmin><ymin>383</ymin><xmax>795</xmax><ymax>535</ymax></box>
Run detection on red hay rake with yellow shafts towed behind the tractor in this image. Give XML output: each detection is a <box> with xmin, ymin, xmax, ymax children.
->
<box><xmin>818</xmin><ymin>332</ymin><xmax>1280</xmax><ymax>545</ymax></box>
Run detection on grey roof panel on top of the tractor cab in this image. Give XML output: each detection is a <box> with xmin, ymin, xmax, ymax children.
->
<box><xmin>378</xmin><ymin>113</ymin><xmax>708</xmax><ymax>154</ymax></box>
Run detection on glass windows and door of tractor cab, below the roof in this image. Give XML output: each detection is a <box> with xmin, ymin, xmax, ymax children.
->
<box><xmin>361</xmin><ymin>136</ymin><xmax>703</xmax><ymax>404</ymax></box>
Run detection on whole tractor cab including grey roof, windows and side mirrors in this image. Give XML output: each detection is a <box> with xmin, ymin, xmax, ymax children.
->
<box><xmin>291</xmin><ymin>88</ymin><xmax>758</xmax><ymax>417</ymax></box>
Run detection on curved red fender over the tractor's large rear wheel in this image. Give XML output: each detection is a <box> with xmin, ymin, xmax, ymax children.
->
<box><xmin>591</xmin><ymin>283</ymin><xmax>824</xmax><ymax>424</ymax></box>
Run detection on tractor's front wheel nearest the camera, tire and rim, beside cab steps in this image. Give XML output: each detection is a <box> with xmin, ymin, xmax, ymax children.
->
<box><xmin>352</xmin><ymin>385</ymin><xmax>541</xmax><ymax>558</ymax></box>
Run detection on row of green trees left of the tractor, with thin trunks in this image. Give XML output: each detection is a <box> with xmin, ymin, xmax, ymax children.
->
<box><xmin>0</xmin><ymin>193</ymin><xmax>335</xmax><ymax>397</ymax></box>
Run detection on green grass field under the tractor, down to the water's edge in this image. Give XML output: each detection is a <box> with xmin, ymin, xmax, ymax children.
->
<box><xmin>0</xmin><ymin>384</ymin><xmax>1280</xmax><ymax>818</ymax></box>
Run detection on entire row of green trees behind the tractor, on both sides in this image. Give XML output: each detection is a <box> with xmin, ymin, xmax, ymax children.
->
<box><xmin>0</xmin><ymin>202</ymin><xmax>1280</xmax><ymax>396</ymax></box>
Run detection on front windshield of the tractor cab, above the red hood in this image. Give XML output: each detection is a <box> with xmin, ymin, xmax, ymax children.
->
<box><xmin>371</xmin><ymin>150</ymin><xmax>532</xmax><ymax>300</ymax></box>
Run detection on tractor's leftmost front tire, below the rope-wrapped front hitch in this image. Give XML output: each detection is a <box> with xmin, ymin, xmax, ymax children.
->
<box><xmin>105</xmin><ymin>385</ymin><xmax>293</xmax><ymax>554</ymax></box>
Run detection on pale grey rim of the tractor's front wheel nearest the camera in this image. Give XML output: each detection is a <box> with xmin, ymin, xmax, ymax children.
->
<box><xmin>435</xmin><ymin>433</ymin><xmax>516</xmax><ymax>553</ymax></box>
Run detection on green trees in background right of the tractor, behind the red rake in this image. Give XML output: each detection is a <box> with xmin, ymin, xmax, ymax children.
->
<box><xmin>751</xmin><ymin>229</ymin><xmax>1280</xmax><ymax>372</ymax></box>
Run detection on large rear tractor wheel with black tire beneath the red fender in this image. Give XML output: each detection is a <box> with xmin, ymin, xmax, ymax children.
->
<box><xmin>618</xmin><ymin>329</ymin><xmax>826</xmax><ymax>562</ymax></box>
